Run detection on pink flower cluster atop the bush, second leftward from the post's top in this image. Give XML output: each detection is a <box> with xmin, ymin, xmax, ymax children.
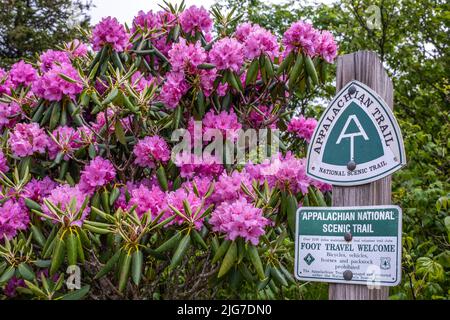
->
<box><xmin>283</xmin><ymin>21</ymin><xmax>320</xmax><ymax>57</ymax></box>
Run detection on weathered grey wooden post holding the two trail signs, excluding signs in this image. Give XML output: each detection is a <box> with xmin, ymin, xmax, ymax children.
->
<box><xmin>329</xmin><ymin>51</ymin><xmax>394</xmax><ymax>300</ymax></box>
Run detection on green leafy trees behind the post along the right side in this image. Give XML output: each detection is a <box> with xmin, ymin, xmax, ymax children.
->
<box><xmin>219</xmin><ymin>0</ymin><xmax>450</xmax><ymax>298</ymax></box>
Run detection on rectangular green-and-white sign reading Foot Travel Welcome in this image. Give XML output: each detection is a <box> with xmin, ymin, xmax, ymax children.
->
<box><xmin>295</xmin><ymin>205</ymin><xmax>402</xmax><ymax>286</ymax></box>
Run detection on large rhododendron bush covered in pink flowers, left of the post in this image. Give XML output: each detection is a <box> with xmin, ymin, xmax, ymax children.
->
<box><xmin>0</xmin><ymin>1</ymin><xmax>337</xmax><ymax>299</ymax></box>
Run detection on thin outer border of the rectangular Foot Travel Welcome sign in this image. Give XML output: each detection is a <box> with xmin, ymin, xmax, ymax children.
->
<box><xmin>294</xmin><ymin>205</ymin><xmax>403</xmax><ymax>286</ymax></box>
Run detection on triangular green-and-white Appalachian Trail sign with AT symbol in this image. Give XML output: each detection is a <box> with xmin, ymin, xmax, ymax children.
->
<box><xmin>307</xmin><ymin>80</ymin><xmax>406</xmax><ymax>186</ymax></box>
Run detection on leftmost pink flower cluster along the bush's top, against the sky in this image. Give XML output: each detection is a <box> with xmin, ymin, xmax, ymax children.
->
<box><xmin>91</xmin><ymin>17</ymin><xmax>130</xmax><ymax>52</ymax></box>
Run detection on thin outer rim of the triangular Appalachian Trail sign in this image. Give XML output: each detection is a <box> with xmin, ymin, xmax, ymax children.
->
<box><xmin>306</xmin><ymin>80</ymin><xmax>406</xmax><ymax>186</ymax></box>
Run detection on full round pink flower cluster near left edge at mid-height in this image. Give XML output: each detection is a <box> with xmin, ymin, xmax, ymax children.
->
<box><xmin>8</xmin><ymin>122</ymin><xmax>50</xmax><ymax>157</ymax></box>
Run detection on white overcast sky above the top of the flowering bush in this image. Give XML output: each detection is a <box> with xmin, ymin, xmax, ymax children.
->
<box><xmin>91</xmin><ymin>0</ymin><xmax>298</xmax><ymax>25</ymax></box>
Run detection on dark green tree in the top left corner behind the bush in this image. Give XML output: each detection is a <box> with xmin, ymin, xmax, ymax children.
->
<box><xmin>0</xmin><ymin>0</ymin><xmax>91</xmax><ymax>67</ymax></box>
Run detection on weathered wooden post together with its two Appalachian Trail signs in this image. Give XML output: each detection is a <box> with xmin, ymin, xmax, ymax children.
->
<box><xmin>302</xmin><ymin>51</ymin><xmax>406</xmax><ymax>300</ymax></box>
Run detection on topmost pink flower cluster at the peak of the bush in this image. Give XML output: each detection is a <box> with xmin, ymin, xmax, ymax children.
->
<box><xmin>180</xmin><ymin>6</ymin><xmax>213</xmax><ymax>35</ymax></box>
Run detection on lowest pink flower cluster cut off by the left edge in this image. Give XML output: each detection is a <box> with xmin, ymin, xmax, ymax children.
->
<box><xmin>0</xmin><ymin>199</ymin><xmax>30</xmax><ymax>240</ymax></box>
